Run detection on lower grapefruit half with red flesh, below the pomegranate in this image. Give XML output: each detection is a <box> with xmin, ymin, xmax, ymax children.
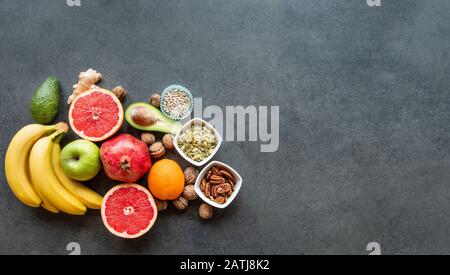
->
<box><xmin>101</xmin><ymin>183</ymin><xmax>158</xmax><ymax>239</ymax></box>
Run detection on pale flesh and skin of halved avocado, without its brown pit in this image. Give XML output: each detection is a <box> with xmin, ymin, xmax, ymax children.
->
<box><xmin>125</xmin><ymin>102</ymin><xmax>182</xmax><ymax>135</ymax></box>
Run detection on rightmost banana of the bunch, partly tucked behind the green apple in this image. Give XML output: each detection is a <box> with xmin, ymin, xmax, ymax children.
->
<box><xmin>53</xmin><ymin>136</ymin><xmax>103</xmax><ymax>209</ymax></box>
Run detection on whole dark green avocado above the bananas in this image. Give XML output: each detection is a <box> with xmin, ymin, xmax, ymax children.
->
<box><xmin>30</xmin><ymin>76</ymin><xmax>60</xmax><ymax>124</ymax></box>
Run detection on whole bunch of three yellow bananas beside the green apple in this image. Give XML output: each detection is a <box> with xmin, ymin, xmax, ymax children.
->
<box><xmin>5</xmin><ymin>122</ymin><xmax>103</xmax><ymax>215</ymax></box>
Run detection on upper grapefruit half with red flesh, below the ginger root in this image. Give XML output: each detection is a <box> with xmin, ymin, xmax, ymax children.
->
<box><xmin>69</xmin><ymin>89</ymin><xmax>124</xmax><ymax>142</ymax></box>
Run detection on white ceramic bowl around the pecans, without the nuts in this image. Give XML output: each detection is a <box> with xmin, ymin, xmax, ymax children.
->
<box><xmin>194</xmin><ymin>161</ymin><xmax>242</xmax><ymax>208</ymax></box>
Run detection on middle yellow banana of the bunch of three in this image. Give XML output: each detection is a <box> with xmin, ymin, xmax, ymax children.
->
<box><xmin>29</xmin><ymin>128</ymin><xmax>87</xmax><ymax>215</ymax></box>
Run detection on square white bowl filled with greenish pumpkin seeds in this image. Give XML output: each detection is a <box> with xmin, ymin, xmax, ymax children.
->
<box><xmin>173</xmin><ymin>118</ymin><xmax>222</xmax><ymax>166</ymax></box>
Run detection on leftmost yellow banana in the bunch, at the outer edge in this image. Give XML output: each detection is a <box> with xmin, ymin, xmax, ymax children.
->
<box><xmin>5</xmin><ymin>124</ymin><xmax>57</xmax><ymax>207</ymax></box>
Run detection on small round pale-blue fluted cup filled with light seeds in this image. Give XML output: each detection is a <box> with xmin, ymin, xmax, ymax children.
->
<box><xmin>160</xmin><ymin>85</ymin><xmax>194</xmax><ymax>120</ymax></box>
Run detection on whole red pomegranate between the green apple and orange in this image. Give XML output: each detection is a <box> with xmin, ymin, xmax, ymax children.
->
<box><xmin>100</xmin><ymin>134</ymin><xmax>152</xmax><ymax>182</ymax></box>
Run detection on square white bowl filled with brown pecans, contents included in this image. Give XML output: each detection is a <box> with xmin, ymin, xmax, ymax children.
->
<box><xmin>194</xmin><ymin>161</ymin><xmax>242</xmax><ymax>208</ymax></box>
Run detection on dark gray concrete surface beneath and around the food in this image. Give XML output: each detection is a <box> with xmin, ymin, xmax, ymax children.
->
<box><xmin>0</xmin><ymin>0</ymin><xmax>450</xmax><ymax>254</ymax></box>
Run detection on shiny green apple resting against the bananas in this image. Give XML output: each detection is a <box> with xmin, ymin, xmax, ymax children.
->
<box><xmin>61</xmin><ymin>139</ymin><xmax>102</xmax><ymax>181</ymax></box>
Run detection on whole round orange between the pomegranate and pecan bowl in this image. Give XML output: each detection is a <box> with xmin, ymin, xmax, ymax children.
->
<box><xmin>148</xmin><ymin>159</ymin><xmax>184</xmax><ymax>200</ymax></box>
